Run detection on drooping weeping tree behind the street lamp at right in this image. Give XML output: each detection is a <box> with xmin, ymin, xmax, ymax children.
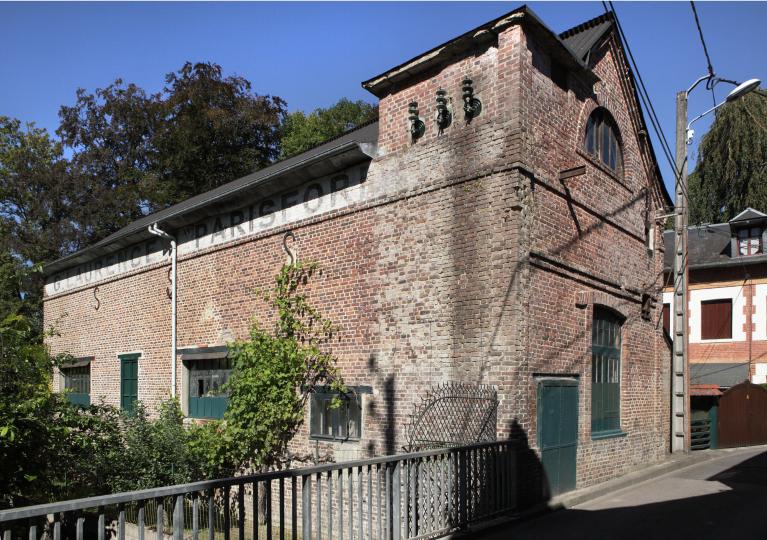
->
<box><xmin>688</xmin><ymin>91</ymin><xmax>767</xmax><ymax>224</ymax></box>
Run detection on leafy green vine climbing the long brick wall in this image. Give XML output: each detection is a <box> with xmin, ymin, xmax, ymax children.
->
<box><xmin>193</xmin><ymin>262</ymin><xmax>347</xmax><ymax>476</ymax></box>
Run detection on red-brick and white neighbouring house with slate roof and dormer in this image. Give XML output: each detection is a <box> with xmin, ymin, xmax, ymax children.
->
<box><xmin>663</xmin><ymin>208</ymin><xmax>767</xmax><ymax>450</ymax></box>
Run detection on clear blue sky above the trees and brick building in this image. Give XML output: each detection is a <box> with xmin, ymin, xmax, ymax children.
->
<box><xmin>0</xmin><ymin>2</ymin><xmax>767</xmax><ymax>197</ymax></box>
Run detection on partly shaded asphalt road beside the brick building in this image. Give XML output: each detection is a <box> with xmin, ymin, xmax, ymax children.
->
<box><xmin>484</xmin><ymin>447</ymin><xmax>767</xmax><ymax>540</ymax></box>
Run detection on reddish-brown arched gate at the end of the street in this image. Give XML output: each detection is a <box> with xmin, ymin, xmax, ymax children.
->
<box><xmin>717</xmin><ymin>382</ymin><xmax>767</xmax><ymax>448</ymax></box>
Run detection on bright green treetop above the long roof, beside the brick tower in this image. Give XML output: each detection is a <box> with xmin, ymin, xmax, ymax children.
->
<box><xmin>281</xmin><ymin>98</ymin><xmax>378</xmax><ymax>158</ymax></box>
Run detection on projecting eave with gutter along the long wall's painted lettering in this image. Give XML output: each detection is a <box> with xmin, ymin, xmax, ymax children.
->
<box><xmin>43</xmin><ymin>133</ymin><xmax>377</xmax><ymax>276</ymax></box>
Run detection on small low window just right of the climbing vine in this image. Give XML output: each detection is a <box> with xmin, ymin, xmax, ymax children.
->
<box><xmin>309</xmin><ymin>388</ymin><xmax>362</xmax><ymax>441</ymax></box>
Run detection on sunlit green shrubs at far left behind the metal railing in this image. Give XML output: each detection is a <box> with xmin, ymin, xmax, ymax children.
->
<box><xmin>0</xmin><ymin>306</ymin><xmax>120</xmax><ymax>508</ymax></box>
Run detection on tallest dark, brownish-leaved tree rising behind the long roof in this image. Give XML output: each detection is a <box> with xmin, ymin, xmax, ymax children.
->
<box><xmin>150</xmin><ymin>62</ymin><xmax>285</xmax><ymax>206</ymax></box>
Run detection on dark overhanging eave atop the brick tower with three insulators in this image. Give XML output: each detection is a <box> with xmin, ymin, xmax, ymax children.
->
<box><xmin>362</xmin><ymin>5</ymin><xmax>596</xmax><ymax>98</ymax></box>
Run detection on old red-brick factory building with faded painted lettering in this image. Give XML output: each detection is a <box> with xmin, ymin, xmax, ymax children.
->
<box><xmin>45</xmin><ymin>7</ymin><xmax>670</xmax><ymax>498</ymax></box>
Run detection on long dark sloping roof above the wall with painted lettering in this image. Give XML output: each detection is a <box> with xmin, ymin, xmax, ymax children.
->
<box><xmin>43</xmin><ymin>120</ymin><xmax>378</xmax><ymax>275</ymax></box>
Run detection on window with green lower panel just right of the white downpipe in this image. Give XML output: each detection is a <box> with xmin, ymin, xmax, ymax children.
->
<box><xmin>185</xmin><ymin>358</ymin><xmax>232</xmax><ymax>419</ymax></box>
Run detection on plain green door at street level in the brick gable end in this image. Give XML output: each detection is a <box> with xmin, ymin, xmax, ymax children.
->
<box><xmin>538</xmin><ymin>379</ymin><xmax>578</xmax><ymax>496</ymax></box>
